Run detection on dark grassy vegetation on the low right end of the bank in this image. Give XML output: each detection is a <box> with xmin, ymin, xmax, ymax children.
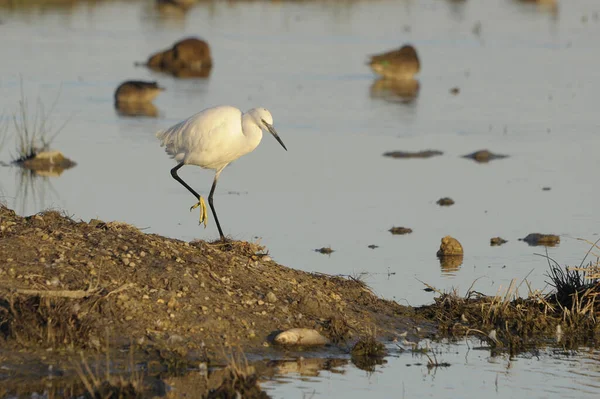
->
<box><xmin>418</xmin><ymin>243</ymin><xmax>600</xmax><ymax>353</ymax></box>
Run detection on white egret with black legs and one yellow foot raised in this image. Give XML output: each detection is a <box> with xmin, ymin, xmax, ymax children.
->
<box><xmin>156</xmin><ymin>105</ymin><xmax>287</xmax><ymax>241</ymax></box>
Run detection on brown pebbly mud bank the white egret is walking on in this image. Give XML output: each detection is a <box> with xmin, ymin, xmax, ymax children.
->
<box><xmin>0</xmin><ymin>207</ymin><xmax>432</xmax><ymax>368</ymax></box>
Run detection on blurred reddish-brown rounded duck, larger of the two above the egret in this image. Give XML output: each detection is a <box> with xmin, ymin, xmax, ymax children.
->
<box><xmin>143</xmin><ymin>37</ymin><xmax>212</xmax><ymax>77</ymax></box>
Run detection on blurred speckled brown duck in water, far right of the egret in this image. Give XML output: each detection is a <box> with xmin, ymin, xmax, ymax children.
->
<box><xmin>369</xmin><ymin>44</ymin><xmax>421</xmax><ymax>79</ymax></box>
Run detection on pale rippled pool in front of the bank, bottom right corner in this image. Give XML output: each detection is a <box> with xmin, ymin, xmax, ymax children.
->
<box><xmin>261</xmin><ymin>342</ymin><xmax>600</xmax><ymax>398</ymax></box>
